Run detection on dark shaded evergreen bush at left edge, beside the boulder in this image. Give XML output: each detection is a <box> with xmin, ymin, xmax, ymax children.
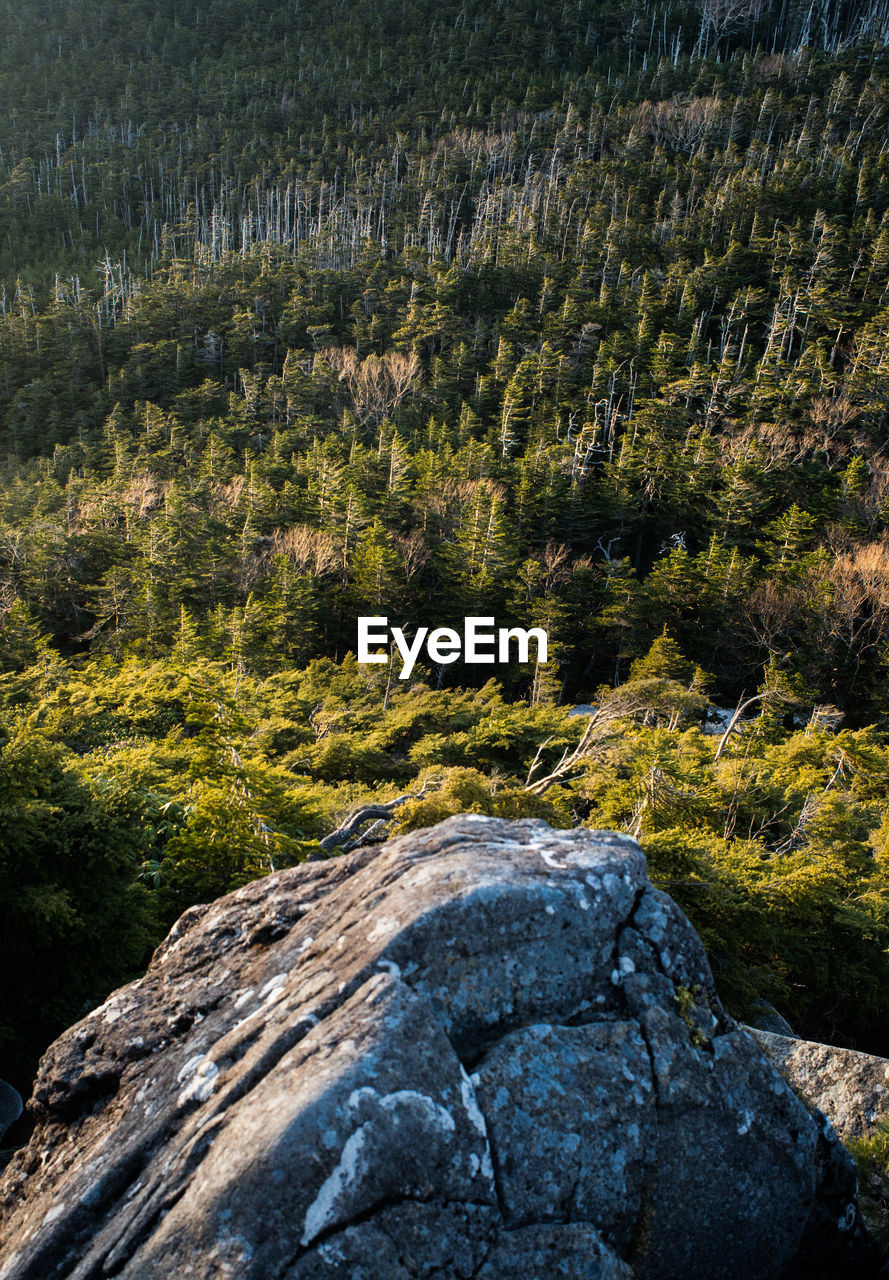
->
<box><xmin>0</xmin><ymin>723</ymin><xmax>159</xmax><ymax>1087</ymax></box>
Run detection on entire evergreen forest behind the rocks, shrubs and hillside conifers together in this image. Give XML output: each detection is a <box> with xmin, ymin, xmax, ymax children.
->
<box><xmin>0</xmin><ymin>0</ymin><xmax>889</xmax><ymax>1111</ymax></box>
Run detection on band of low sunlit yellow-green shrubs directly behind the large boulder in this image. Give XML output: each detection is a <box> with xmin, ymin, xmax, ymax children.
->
<box><xmin>0</xmin><ymin>636</ymin><xmax>889</xmax><ymax>1080</ymax></box>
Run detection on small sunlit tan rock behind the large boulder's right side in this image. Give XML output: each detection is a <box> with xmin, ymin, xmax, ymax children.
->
<box><xmin>751</xmin><ymin>1028</ymin><xmax>889</xmax><ymax>1142</ymax></box>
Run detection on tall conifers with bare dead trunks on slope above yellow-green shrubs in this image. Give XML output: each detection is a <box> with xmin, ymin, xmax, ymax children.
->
<box><xmin>0</xmin><ymin>24</ymin><xmax>889</xmax><ymax>716</ymax></box>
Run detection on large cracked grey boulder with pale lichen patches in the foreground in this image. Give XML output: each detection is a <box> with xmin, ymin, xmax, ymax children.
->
<box><xmin>0</xmin><ymin>815</ymin><xmax>872</xmax><ymax>1280</ymax></box>
